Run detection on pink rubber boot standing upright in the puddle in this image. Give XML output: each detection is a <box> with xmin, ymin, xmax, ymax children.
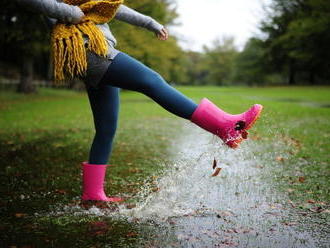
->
<box><xmin>82</xmin><ymin>162</ymin><xmax>123</xmax><ymax>202</ymax></box>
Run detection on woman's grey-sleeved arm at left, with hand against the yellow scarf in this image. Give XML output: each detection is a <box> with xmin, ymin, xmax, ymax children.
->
<box><xmin>17</xmin><ymin>0</ymin><xmax>84</xmax><ymax>23</ymax></box>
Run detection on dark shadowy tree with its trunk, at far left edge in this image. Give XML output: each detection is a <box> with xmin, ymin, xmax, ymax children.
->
<box><xmin>0</xmin><ymin>0</ymin><xmax>49</xmax><ymax>93</ymax></box>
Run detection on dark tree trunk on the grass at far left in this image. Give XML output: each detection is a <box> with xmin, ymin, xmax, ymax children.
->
<box><xmin>17</xmin><ymin>56</ymin><xmax>36</xmax><ymax>94</ymax></box>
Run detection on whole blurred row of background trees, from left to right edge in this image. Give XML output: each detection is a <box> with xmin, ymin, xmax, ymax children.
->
<box><xmin>0</xmin><ymin>0</ymin><xmax>330</xmax><ymax>89</ymax></box>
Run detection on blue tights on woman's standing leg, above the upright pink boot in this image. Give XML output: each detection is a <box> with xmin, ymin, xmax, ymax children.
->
<box><xmin>87</xmin><ymin>85</ymin><xmax>119</xmax><ymax>165</ymax></box>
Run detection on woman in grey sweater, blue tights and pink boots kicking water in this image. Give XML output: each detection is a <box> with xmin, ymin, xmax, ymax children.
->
<box><xmin>17</xmin><ymin>0</ymin><xmax>262</xmax><ymax>202</ymax></box>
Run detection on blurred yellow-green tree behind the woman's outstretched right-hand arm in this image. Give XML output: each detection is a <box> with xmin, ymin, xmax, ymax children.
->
<box><xmin>110</xmin><ymin>0</ymin><xmax>186</xmax><ymax>82</ymax></box>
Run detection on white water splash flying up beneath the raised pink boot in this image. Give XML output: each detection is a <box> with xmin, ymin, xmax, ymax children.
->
<box><xmin>121</xmin><ymin>123</ymin><xmax>276</xmax><ymax>219</ymax></box>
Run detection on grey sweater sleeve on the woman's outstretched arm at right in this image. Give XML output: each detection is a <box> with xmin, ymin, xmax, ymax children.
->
<box><xmin>115</xmin><ymin>5</ymin><xmax>163</xmax><ymax>33</ymax></box>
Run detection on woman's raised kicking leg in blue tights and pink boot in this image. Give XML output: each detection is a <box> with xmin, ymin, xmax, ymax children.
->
<box><xmin>101</xmin><ymin>53</ymin><xmax>262</xmax><ymax>148</ymax></box>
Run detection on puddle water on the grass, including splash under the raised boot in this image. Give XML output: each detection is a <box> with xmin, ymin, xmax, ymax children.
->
<box><xmin>49</xmin><ymin>124</ymin><xmax>330</xmax><ymax>248</ymax></box>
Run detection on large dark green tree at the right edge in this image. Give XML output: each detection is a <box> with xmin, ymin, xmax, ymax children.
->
<box><xmin>262</xmin><ymin>0</ymin><xmax>330</xmax><ymax>84</ymax></box>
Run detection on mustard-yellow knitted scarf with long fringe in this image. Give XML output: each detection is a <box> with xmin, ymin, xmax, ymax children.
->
<box><xmin>51</xmin><ymin>0</ymin><xmax>123</xmax><ymax>84</ymax></box>
